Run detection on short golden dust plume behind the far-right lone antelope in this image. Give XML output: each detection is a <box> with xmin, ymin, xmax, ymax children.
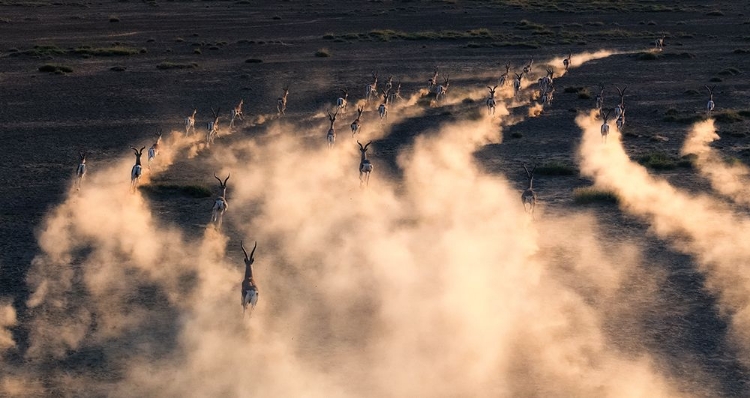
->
<box><xmin>680</xmin><ymin>119</ymin><xmax>750</xmax><ymax>205</ymax></box>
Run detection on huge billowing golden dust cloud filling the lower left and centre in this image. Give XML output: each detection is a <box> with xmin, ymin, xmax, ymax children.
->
<box><xmin>0</xmin><ymin>70</ymin><xmax>700</xmax><ymax>398</ymax></box>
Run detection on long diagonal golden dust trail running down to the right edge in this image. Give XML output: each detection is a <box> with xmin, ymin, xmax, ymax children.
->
<box><xmin>576</xmin><ymin>112</ymin><xmax>750</xmax><ymax>364</ymax></box>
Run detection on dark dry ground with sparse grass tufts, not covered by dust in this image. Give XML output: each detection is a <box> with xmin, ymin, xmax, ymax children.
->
<box><xmin>0</xmin><ymin>0</ymin><xmax>750</xmax><ymax>397</ymax></box>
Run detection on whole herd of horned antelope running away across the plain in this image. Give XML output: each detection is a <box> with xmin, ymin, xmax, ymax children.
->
<box><xmin>74</xmin><ymin>37</ymin><xmax>715</xmax><ymax>313</ymax></box>
